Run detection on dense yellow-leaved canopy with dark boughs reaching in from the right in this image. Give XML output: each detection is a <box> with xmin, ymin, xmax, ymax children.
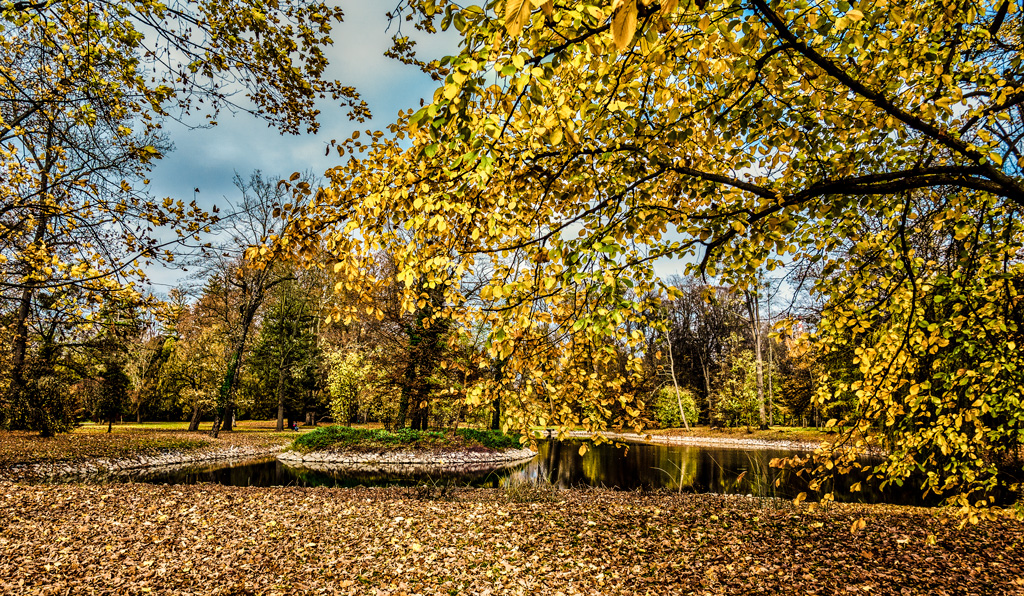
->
<box><xmin>281</xmin><ymin>0</ymin><xmax>1024</xmax><ymax>515</ymax></box>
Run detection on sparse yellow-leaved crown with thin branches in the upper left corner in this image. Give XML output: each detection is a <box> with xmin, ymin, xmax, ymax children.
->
<box><xmin>0</xmin><ymin>1</ymin><xmax>367</xmax><ymax>432</ymax></box>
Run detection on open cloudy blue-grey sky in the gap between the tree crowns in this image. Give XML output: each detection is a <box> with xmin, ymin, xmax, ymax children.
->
<box><xmin>140</xmin><ymin>0</ymin><xmax>459</xmax><ymax>294</ymax></box>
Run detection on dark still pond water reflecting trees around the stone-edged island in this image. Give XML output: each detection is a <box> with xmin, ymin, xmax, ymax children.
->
<box><xmin>105</xmin><ymin>440</ymin><xmax>937</xmax><ymax>505</ymax></box>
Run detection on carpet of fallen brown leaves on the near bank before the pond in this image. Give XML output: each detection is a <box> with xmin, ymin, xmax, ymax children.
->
<box><xmin>0</xmin><ymin>483</ymin><xmax>1024</xmax><ymax>596</ymax></box>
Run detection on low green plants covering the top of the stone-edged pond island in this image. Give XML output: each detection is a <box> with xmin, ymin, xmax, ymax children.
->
<box><xmin>292</xmin><ymin>426</ymin><xmax>519</xmax><ymax>453</ymax></box>
